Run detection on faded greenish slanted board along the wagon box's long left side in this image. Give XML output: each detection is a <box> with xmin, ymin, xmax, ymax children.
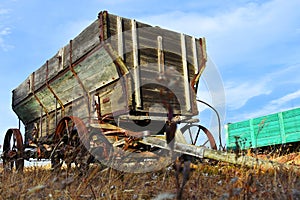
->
<box><xmin>14</xmin><ymin>48</ymin><xmax>118</xmax><ymax>125</ymax></box>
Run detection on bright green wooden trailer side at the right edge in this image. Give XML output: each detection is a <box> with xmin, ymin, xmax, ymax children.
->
<box><xmin>225</xmin><ymin>108</ymin><xmax>300</xmax><ymax>150</ymax></box>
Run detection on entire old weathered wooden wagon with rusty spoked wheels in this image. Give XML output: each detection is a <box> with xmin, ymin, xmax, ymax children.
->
<box><xmin>2</xmin><ymin>11</ymin><xmax>216</xmax><ymax>169</ymax></box>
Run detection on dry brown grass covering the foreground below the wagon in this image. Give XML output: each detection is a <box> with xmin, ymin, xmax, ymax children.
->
<box><xmin>0</xmin><ymin>159</ymin><xmax>300</xmax><ymax>199</ymax></box>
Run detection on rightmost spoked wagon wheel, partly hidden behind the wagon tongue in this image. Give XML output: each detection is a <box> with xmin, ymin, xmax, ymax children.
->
<box><xmin>181</xmin><ymin>124</ymin><xmax>217</xmax><ymax>150</ymax></box>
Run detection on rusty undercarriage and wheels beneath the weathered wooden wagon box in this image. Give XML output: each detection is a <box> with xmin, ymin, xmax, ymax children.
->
<box><xmin>2</xmin><ymin>112</ymin><xmax>216</xmax><ymax>172</ymax></box>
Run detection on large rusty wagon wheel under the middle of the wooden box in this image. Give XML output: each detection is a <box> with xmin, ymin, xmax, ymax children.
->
<box><xmin>50</xmin><ymin>116</ymin><xmax>89</xmax><ymax>169</ymax></box>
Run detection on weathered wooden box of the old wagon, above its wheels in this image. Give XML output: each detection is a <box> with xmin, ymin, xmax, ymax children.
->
<box><xmin>12</xmin><ymin>11</ymin><xmax>206</xmax><ymax>140</ymax></box>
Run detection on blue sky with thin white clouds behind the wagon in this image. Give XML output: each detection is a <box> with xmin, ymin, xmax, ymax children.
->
<box><xmin>0</xmin><ymin>0</ymin><xmax>300</xmax><ymax>147</ymax></box>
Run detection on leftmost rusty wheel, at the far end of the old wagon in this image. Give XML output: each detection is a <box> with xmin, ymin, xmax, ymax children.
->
<box><xmin>2</xmin><ymin>129</ymin><xmax>24</xmax><ymax>171</ymax></box>
